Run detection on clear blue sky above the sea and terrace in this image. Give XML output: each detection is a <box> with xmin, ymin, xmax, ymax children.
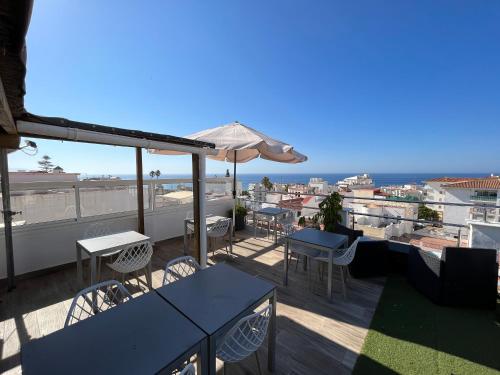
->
<box><xmin>9</xmin><ymin>0</ymin><xmax>500</xmax><ymax>174</ymax></box>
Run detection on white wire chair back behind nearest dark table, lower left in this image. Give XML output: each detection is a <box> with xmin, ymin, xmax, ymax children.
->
<box><xmin>64</xmin><ymin>280</ymin><xmax>132</xmax><ymax>327</ymax></box>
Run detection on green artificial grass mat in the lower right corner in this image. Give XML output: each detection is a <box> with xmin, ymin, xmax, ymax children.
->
<box><xmin>353</xmin><ymin>276</ymin><xmax>500</xmax><ymax>374</ymax></box>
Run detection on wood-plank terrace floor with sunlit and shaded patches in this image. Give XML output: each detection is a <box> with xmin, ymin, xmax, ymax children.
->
<box><xmin>0</xmin><ymin>228</ymin><xmax>384</xmax><ymax>374</ymax></box>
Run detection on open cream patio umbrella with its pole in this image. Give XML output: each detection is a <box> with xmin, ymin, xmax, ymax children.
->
<box><xmin>150</xmin><ymin>121</ymin><xmax>307</xmax><ymax>229</ymax></box>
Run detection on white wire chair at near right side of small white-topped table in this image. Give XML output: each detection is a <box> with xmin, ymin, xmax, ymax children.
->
<box><xmin>107</xmin><ymin>241</ymin><xmax>153</xmax><ymax>288</ymax></box>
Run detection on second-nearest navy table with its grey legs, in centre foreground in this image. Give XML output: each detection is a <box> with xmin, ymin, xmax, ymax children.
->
<box><xmin>156</xmin><ymin>263</ymin><xmax>276</xmax><ymax>374</ymax></box>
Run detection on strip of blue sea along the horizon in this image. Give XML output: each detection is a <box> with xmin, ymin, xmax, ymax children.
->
<box><xmin>82</xmin><ymin>172</ymin><xmax>498</xmax><ymax>190</ymax></box>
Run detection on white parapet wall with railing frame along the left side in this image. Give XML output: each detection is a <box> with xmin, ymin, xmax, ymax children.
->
<box><xmin>0</xmin><ymin>179</ymin><xmax>232</xmax><ymax>279</ymax></box>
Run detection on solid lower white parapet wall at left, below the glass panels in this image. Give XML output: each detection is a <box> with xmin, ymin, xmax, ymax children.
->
<box><xmin>0</xmin><ymin>198</ymin><xmax>232</xmax><ymax>279</ymax></box>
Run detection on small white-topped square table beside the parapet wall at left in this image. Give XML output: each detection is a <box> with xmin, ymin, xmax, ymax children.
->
<box><xmin>76</xmin><ymin>230</ymin><xmax>152</xmax><ymax>288</ymax></box>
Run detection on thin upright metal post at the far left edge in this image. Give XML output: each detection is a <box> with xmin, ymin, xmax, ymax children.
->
<box><xmin>0</xmin><ymin>148</ymin><xmax>15</xmax><ymax>291</ymax></box>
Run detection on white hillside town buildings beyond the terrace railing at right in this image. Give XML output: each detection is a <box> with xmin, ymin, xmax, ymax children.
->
<box><xmin>248</xmin><ymin>174</ymin><xmax>500</xmax><ymax>250</ymax></box>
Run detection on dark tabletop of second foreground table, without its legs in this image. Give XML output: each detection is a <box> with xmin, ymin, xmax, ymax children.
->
<box><xmin>156</xmin><ymin>263</ymin><xmax>275</xmax><ymax>335</ymax></box>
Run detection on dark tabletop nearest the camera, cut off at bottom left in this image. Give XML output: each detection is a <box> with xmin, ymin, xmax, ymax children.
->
<box><xmin>21</xmin><ymin>292</ymin><xmax>206</xmax><ymax>374</ymax></box>
